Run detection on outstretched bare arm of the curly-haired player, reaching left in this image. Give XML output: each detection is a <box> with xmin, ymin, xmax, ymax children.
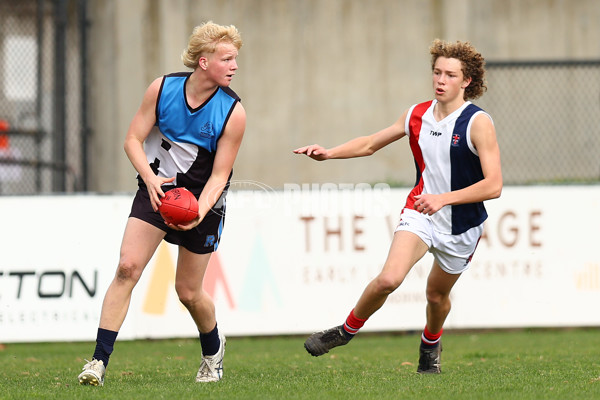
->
<box><xmin>294</xmin><ymin>110</ymin><xmax>408</xmax><ymax>161</ymax></box>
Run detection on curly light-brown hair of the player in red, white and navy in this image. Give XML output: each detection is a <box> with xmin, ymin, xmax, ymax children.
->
<box><xmin>429</xmin><ymin>39</ymin><xmax>487</xmax><ymax>100</ymax></box>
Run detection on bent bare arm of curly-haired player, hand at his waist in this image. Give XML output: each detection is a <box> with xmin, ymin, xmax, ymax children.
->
<box><xmin>415</xmin><ymin>114</ymin><xmax>502</xmax><ymax>215</ymax></box>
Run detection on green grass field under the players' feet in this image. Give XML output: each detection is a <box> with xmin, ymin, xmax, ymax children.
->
<box><xmin>0</xmin><ymin>329</ymin><xmax>600</xmax><ymax>400</ymax></box>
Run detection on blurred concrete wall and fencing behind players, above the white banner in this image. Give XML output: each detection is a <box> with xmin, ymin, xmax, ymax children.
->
<box><xmin>0</xmin><ymin>0</ymin><xmax>600</xmax><ymax>195</ymax></box>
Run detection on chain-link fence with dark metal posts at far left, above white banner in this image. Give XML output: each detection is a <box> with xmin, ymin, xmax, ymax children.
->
<box><xmin>0</xmin><ymin>0</ymin><xmax>86</xmax><ymax>195</ymax></box>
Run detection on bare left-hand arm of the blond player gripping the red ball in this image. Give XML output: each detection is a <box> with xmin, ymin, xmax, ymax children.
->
<box><xmin>123</xmin><ymin>78</ymin><xmax>175</xmax><ymax>211</ymax></box>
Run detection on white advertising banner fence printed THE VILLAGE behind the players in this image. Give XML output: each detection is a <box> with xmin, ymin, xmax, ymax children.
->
<box><xmin>0</xmin><ymin>184</ymin><xmax>600</xmax><ymax>342</ymax></box>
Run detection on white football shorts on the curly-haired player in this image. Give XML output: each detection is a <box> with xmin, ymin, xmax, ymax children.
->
<box><xmin>394</xmin><ymin>208</ymin><xmax>483</xmax><ymax>274</ymax></box>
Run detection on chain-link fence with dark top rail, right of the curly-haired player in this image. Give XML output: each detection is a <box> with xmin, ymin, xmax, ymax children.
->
<box><xmin>476</xmin><ymin>60</ymin><xmax>600</xmax><ymax>185</ymax></box>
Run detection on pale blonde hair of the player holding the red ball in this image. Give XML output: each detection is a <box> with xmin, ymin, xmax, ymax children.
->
<box><xmin>181</xmin><ymin>21</ymin><xmax>242</xmax><ymax>69</ymax></box>
